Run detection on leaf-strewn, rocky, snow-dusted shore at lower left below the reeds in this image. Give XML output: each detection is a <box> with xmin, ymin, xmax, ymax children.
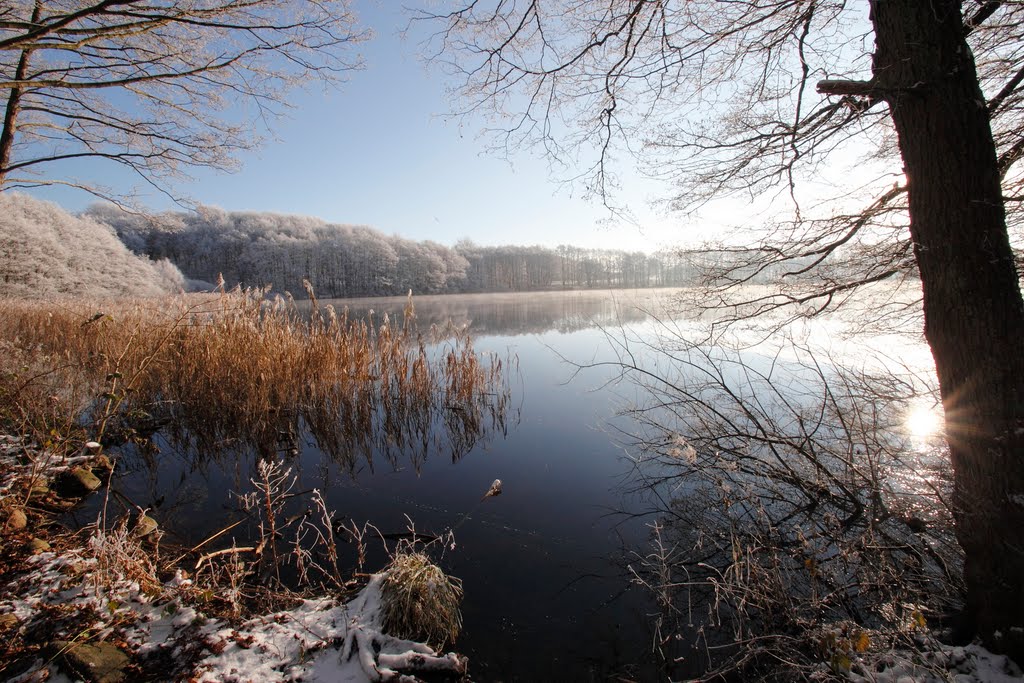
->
<box><xmin>0</xmin><ymin>434</ymin><xmax>467</xmax><ymax>683</ymax></box>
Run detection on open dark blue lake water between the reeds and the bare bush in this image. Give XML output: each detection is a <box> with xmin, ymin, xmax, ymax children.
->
<box><xmin>80</xmin><ymin>291</ymin><xmax>679</xmax><ymax>681</ymax></box>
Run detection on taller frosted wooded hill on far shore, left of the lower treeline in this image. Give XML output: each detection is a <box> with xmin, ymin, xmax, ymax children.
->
<box><xmin>86</xmin><ymin>205</ymin><xmax>468</xmax><ymax>297</ymax></box>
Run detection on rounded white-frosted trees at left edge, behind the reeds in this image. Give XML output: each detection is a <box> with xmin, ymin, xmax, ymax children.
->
<box><xmin>0</xmin><ymin>193</ymin><xmax>184</xmax><ymax>298</ymax></box>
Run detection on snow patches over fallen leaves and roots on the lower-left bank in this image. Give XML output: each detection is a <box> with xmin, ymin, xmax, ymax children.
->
<box><xmin>0</xmin><ymin>552</ymin><xmax>466</xmax><ymax>683</ymax></box>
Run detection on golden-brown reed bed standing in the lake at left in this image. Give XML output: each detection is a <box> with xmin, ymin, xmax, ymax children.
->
<box><xmin>0</xmin><ymin>290</ymin><xmax>509</xmax><ymax>467</ymax></box>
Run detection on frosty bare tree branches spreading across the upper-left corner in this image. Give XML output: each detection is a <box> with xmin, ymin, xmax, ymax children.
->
<box><xmin>0</xmin><ymin>0</ymin><xmax>368</xmax><ymax>201</ymax></box>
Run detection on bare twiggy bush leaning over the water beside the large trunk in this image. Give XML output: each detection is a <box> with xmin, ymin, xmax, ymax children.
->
<box><xmin>608</xmin><ymin>327</ymin><xmax>963</xmax><ymax>680</ymax></box>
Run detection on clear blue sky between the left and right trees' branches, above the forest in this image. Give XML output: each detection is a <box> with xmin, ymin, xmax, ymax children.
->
<box><xmin>29</xmin><ymin>0</ymin><xmax>694</xmax><ymax>250</ymax></box>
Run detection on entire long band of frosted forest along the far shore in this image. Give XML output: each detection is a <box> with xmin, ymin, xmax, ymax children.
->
<box><xmin>86</xmin><ymin>205</ymin><xmax>782</xmax><ymax>298</ymax></box>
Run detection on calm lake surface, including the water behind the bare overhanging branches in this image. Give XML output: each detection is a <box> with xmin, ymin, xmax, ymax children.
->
<box><xmin>75</xmin><ymin>291</ymin><xmax>944</xmax><ymax>680</ymax></box>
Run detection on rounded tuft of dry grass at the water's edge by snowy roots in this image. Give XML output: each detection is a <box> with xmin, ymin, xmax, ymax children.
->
<box><xmin>381</xmin><ymin>551</ymin><xmax>462</xmax><ymax>650</ymax></box>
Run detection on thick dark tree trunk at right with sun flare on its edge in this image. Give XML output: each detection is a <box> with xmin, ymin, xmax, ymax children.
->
<box><xmin>871</xmin><ymin>0</ymin><xmax>1024</xmax><ymax>663</ymax></box>
